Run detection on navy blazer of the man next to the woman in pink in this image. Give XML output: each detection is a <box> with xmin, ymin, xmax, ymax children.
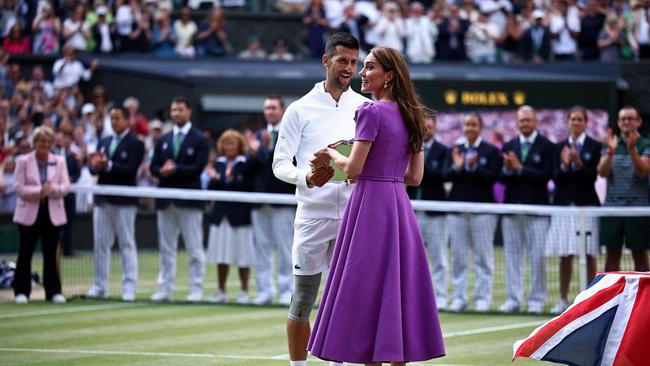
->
<box><xmin>90</xmin><ymin>132</ymin><xmax>144</xmax><ymax>205</ymax></box>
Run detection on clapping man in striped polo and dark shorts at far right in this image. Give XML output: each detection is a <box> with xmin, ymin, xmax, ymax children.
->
<box><xmin>598</xmin><ymin>106</ymin><xmax>650</xmax><ymax>272</ymax></box>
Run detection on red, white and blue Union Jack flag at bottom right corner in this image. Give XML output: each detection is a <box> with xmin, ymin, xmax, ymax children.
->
<box><xmin>513</xmin><ymin>272</ymin><xmax>650</xmax><ymax>366</ymax></box>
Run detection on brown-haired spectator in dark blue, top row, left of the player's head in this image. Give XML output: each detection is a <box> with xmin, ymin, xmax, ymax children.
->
<box><xmin>196</xmin><ymin>8</ymin><xmax>229</xmax><ymax>56</ymax></box>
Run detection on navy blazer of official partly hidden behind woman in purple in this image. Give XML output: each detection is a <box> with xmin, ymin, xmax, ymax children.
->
<box><xmin>406</xmin><ymin>141</ymin><xmax>449</xmax><ymax>207</ymax></box>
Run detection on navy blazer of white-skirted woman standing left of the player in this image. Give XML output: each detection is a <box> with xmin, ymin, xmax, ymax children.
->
<box><xmin>208</xmin><ymin>156</ymin><xmax>253</xmax><ymax>227</ymax></box>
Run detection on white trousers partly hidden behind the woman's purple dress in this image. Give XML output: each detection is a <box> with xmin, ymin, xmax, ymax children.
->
<box><xmin>417</xmin><ymin>212</ymin><xmax>449</xmax><ymax>306</ymax></box>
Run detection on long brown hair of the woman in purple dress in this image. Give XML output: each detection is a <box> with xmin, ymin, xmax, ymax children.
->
<box><xmin>370</xmin><ymin>47</ymin><xmax>424</xmax><ymax>154</ymax></box>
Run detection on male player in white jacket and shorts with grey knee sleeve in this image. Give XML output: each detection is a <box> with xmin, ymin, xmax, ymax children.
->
<box><xmin>273</xmin><ymin>33</ymin><xmax>368</xmax><ymax>366</ymax></box>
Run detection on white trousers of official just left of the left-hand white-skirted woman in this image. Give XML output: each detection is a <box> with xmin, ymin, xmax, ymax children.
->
<box><xmin>156</xmin><ymin>205</ymin><xmax>205</xmax><ymax>293</ymax></box>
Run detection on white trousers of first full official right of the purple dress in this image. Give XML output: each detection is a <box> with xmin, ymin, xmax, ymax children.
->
<box><xmin>447</xmin><ymin>214</ymin><xmax>498</xmax><ymax>307</ymax></box>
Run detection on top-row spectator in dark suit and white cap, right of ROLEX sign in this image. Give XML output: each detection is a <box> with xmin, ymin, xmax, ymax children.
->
<box><xmin>519</xmin><ymin>9</ymin><xmax>551</xmax><ymax>64</ymax></box>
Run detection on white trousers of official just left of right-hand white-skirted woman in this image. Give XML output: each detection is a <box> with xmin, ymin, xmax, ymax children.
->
<box><xmin>502</xmin><ymin>215</ymin><xmax>549</xmax><ymax>307</ymax></box>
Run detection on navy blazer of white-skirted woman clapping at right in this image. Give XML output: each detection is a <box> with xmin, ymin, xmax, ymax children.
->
<box><xmin>553</xmin><ymin>136</ymin><xmax>602</xmax><ymax>206</ymax></box>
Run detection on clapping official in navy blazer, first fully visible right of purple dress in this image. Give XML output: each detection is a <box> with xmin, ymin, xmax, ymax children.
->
<box><xmin>447</xmin><ymin>113</ymin><xmax>501</xmax><ymax>312</ymax></box>
